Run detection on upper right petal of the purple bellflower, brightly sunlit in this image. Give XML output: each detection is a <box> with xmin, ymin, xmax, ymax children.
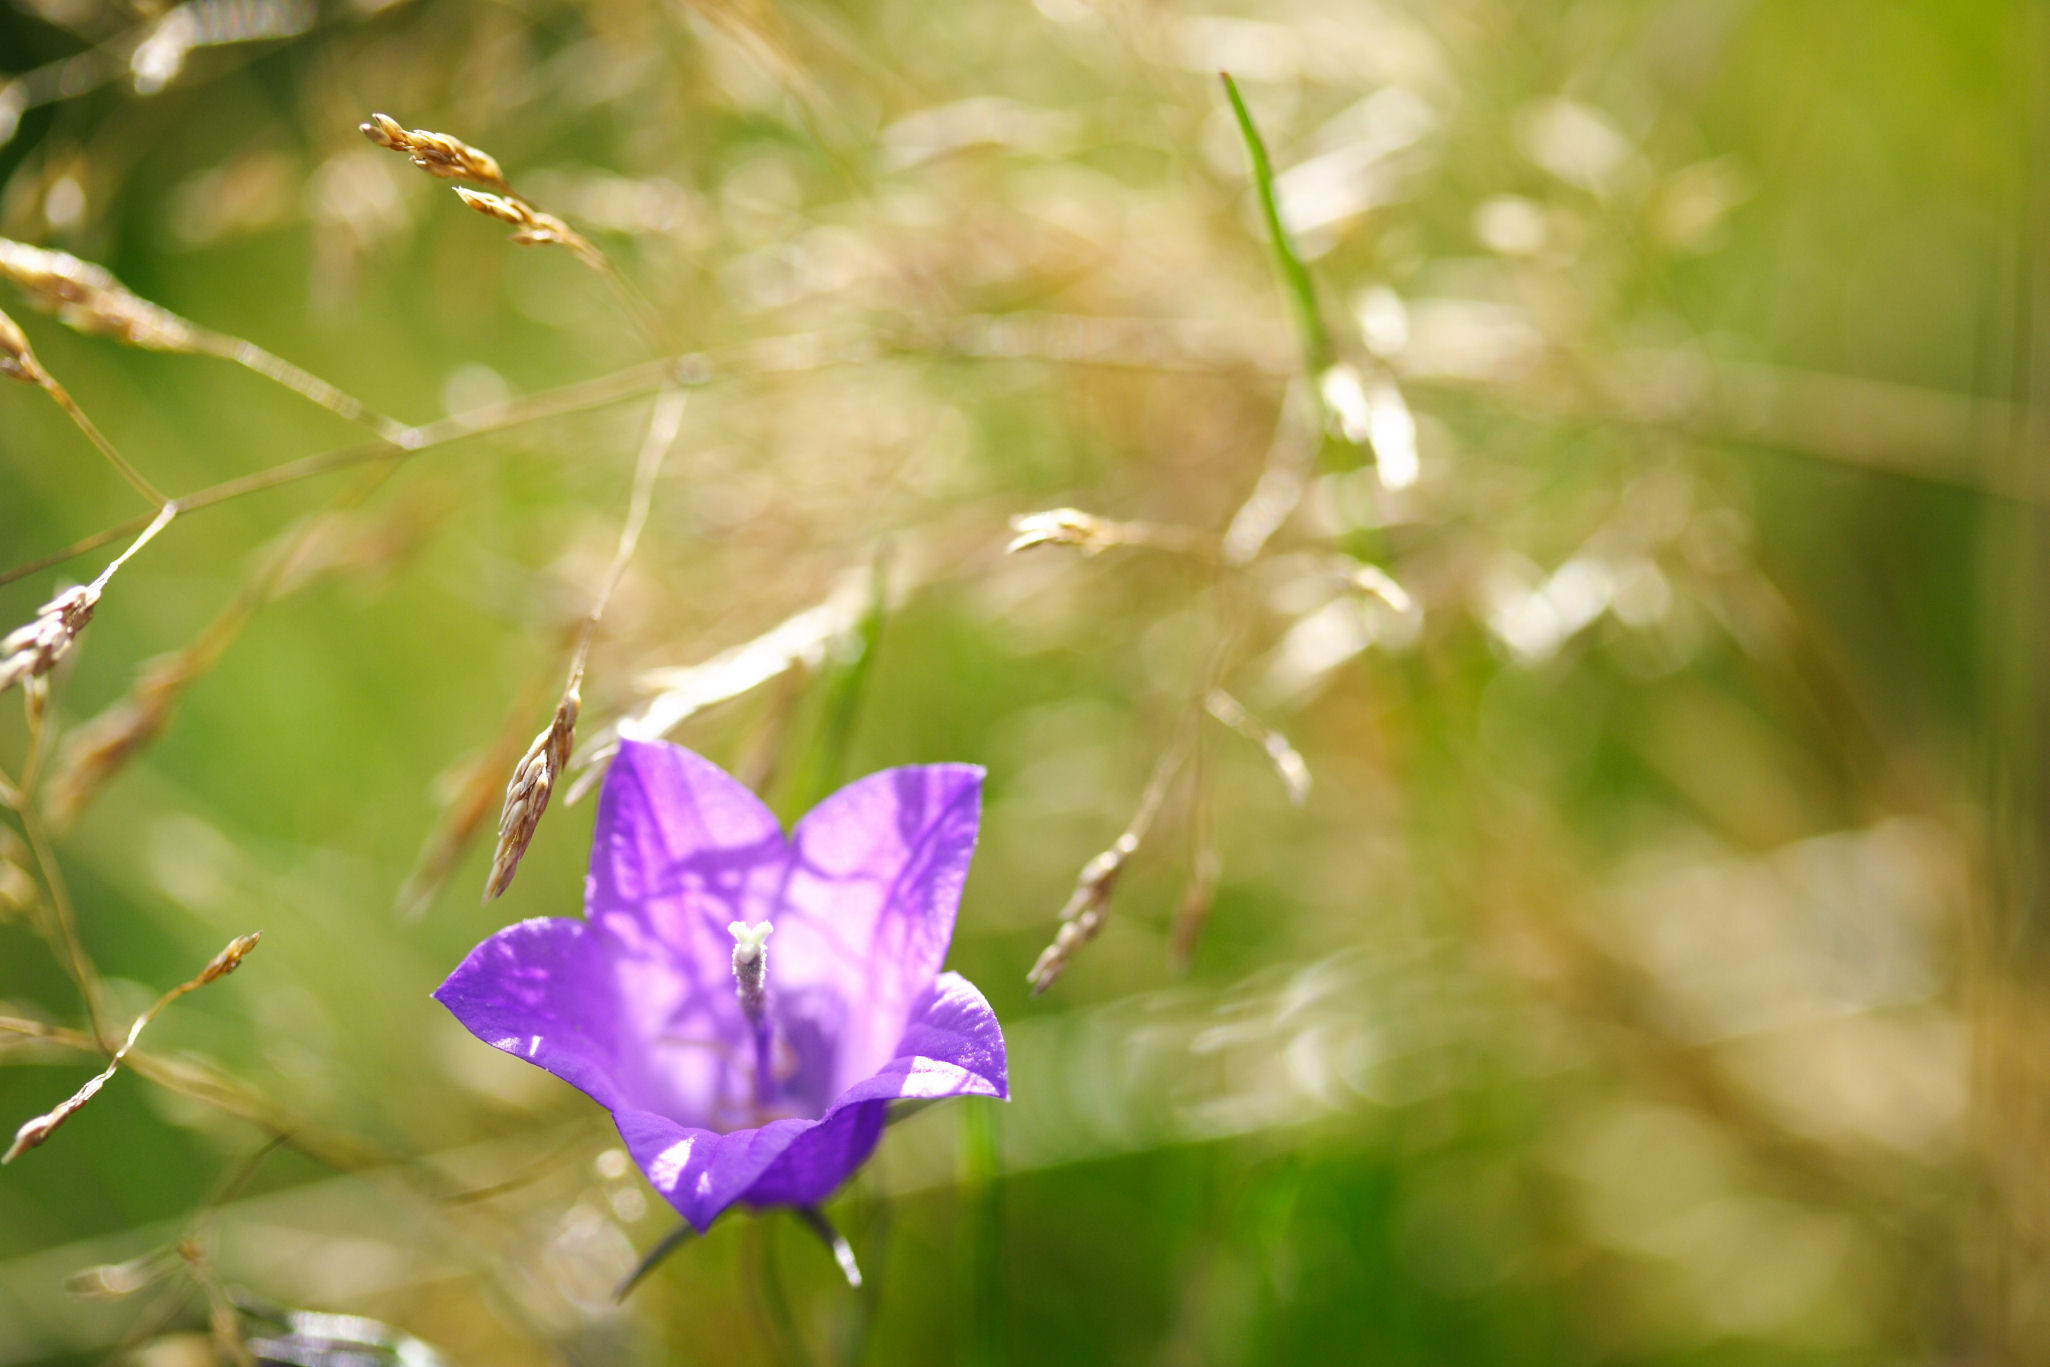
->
<box><xmin>771</xmin><ymin>764</ymin><xmax>982</xmax><ymax>1090</ymax></box>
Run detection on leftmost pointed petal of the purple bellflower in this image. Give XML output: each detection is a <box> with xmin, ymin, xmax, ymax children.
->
<box><xmin>435</xmin><ymin>916</ymin><xmax>636</xmax><ymax>1107</ymax></box>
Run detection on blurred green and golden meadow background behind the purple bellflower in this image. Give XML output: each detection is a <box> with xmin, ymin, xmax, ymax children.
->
<box><xmin>0</xmin><ymin>0</ymin><xmax>2050</xmax><ymax>1367</ymax></box>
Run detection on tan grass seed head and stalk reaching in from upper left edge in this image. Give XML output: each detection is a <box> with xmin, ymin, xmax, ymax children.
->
<box><xmin>0</xmin><ymin>238</ymin><xmax>412</xmax><ymax>444</ymax></box>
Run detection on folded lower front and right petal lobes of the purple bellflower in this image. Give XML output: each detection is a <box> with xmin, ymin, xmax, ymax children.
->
<box><xmin>613</xmin><ymin>974</ymin><xmax>1011</xmax><ymax>1232</ymax></box>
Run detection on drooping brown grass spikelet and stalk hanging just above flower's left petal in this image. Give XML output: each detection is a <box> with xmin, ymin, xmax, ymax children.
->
<box><xmin>484</xmin><ymin>389</ymin><xmax>685</xmax><ymax>902</ymax></box>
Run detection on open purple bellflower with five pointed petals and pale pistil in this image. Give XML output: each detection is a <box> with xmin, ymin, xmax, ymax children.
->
<box><xmin>435</xmin><ymin>742</ymin><xmax>1011</xmax><ymax>1230</ymax></box>
